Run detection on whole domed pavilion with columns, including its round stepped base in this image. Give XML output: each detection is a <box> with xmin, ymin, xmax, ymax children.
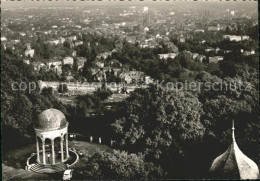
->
<box><xmin>27</xmin><ymin>109</ymin><xmax>78</xmax><ymax>173</ymax></box>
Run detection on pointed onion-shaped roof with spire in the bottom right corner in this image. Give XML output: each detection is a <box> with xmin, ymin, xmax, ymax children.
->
<box><xmin>210</xmin><ymin>122</ymin><xmax>259</xmax><ymax>179</ymax></box>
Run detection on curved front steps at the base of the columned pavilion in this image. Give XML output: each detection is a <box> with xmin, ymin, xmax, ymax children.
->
<box><xmin>30</xmin><ymin>163</ymin><xmax>67</xmax><ymax>173</ymax></box>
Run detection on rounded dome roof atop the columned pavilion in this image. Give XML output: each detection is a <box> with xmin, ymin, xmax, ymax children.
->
<box><xmin>34</xmin><ymin>109</ymin><xmax>68</xmax><ymax>131</ymax></box>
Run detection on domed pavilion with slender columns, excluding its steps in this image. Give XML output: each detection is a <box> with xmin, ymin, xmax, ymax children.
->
<box><xmin>34</xmin><ymin>109</ymin><xmax>69</xmax><ymax>164</ymax></box>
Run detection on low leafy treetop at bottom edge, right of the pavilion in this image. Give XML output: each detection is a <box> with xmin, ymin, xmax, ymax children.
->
<box><xmin>74</xmin><ymin>150</ymin><xmax>163</xmax><ymax>180</ymax></box>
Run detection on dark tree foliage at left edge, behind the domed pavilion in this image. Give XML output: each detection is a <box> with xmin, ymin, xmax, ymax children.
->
<box><xmin>1</xmin><ymin>49</ymin><xmax>66</xmax><ymax>153</ymax></box>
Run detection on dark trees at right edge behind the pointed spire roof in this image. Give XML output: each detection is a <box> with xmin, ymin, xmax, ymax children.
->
<box><xmin>196</xmin><ymin>71</ymin><xmax>259</xmax><ymax>166</ymax></box>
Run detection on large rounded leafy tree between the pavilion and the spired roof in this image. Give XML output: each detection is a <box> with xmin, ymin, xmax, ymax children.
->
<box><xmin>112</xmin><ymin>86</ymin><xmax>205</xmax><ymax>165</ymax></box>
